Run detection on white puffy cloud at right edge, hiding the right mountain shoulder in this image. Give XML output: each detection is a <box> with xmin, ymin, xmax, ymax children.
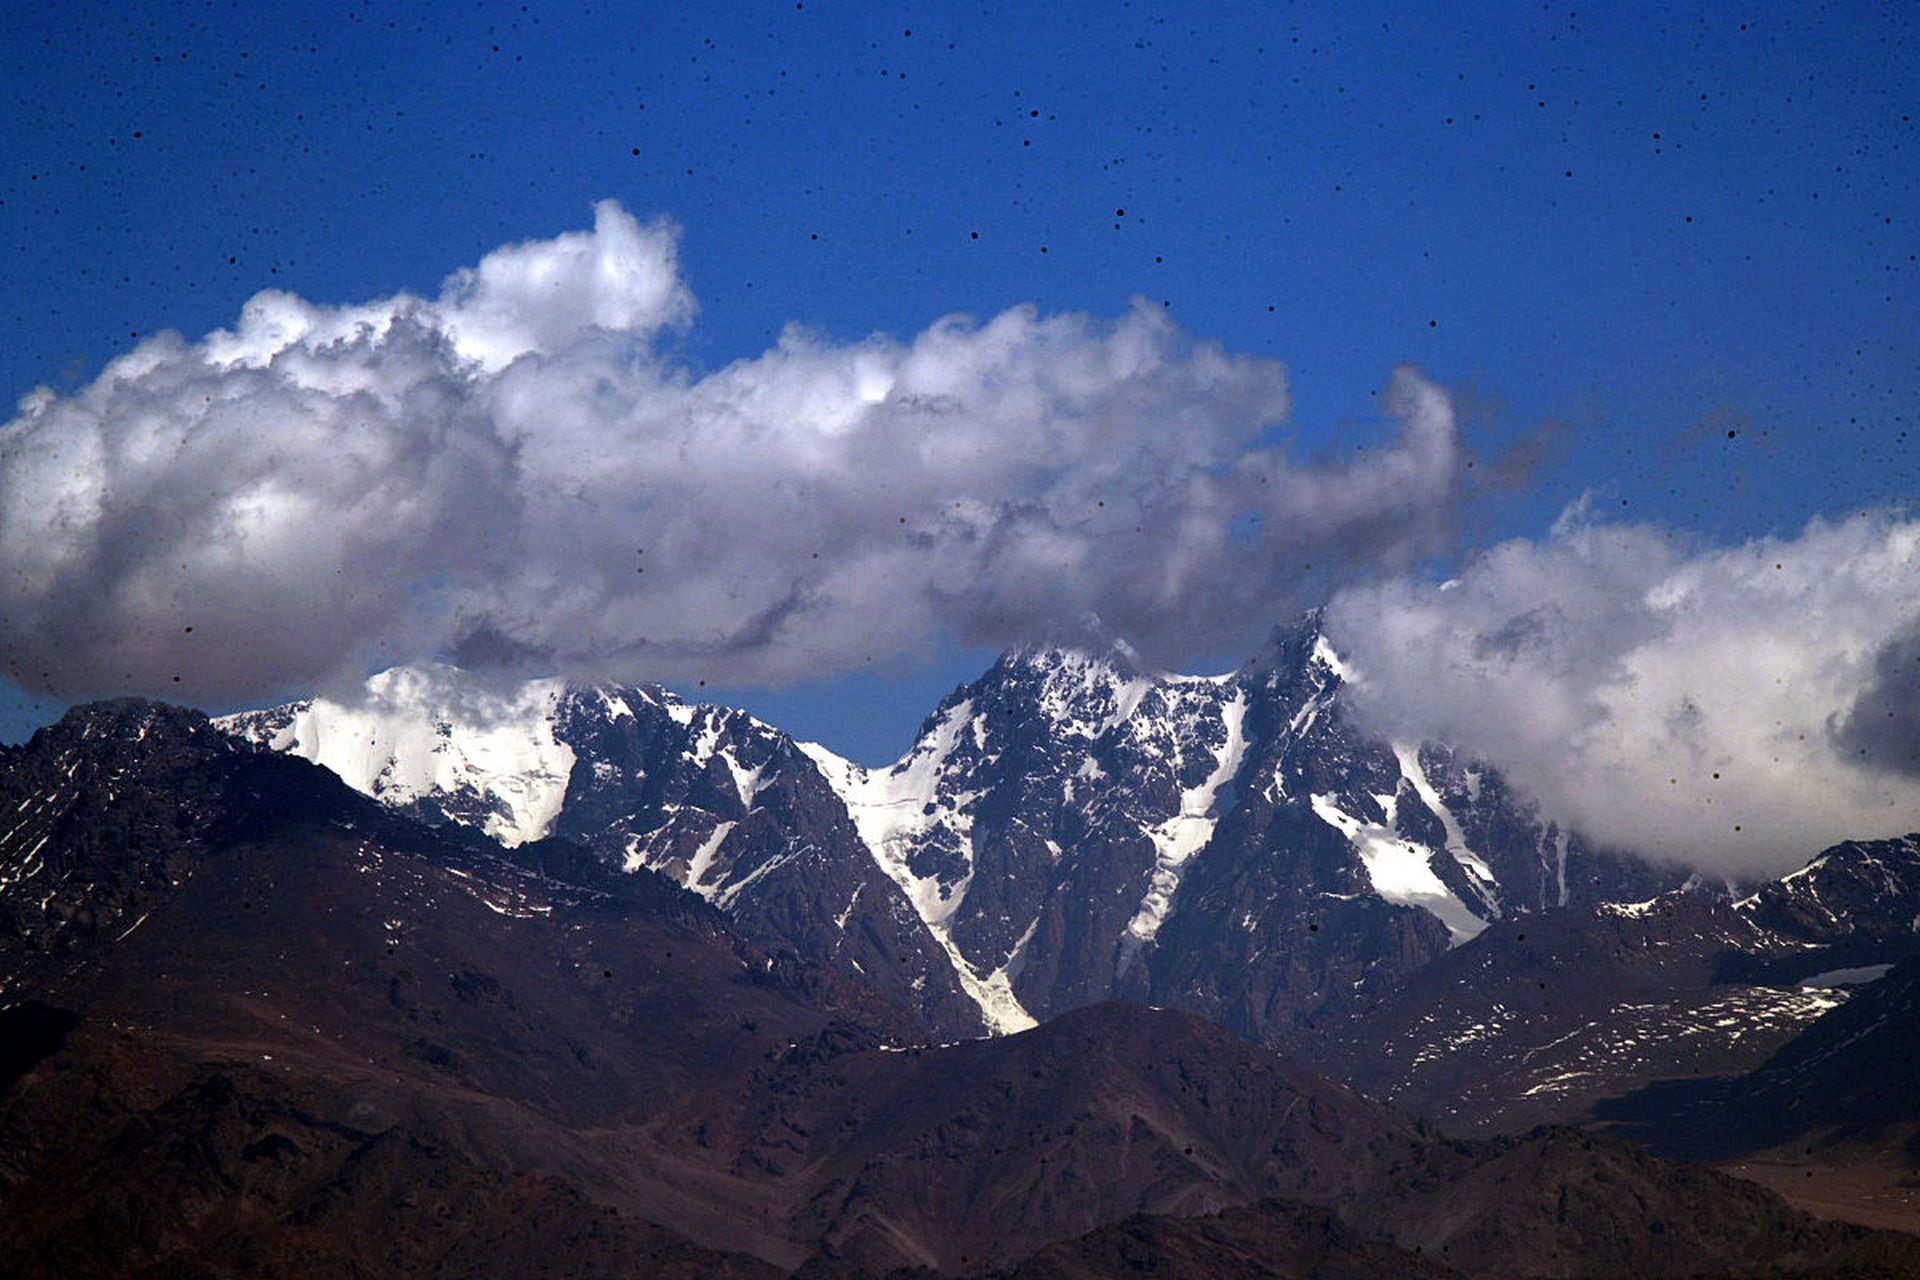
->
<box><xmin>1327</xmin><ymin>509</ymin><xmax>1920</xmax><ymax>877</ymax></box>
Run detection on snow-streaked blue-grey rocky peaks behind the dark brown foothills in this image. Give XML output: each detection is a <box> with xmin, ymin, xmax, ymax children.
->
<box><xmin>225</xmin><ymin>616</ymin><xmax>1678</xmax><ymax>1038</ymax></box>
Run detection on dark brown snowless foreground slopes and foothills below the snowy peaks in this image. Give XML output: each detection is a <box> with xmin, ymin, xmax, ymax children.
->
<box><xmin>0</xmin><ymin>704</ymin><xmax>1912</xmax><ymax>1280</ymax></box>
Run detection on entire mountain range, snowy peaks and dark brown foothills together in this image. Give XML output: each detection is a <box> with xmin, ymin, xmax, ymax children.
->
<box><xmin>0</xmin><ymin>616</ymin><xmax>1920</xmax><ymax>1276</ymax></box>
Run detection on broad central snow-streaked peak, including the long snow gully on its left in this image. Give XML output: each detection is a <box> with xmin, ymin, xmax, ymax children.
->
<box><xmin>802</xmin><ymin>651</ymin><xmax>1246</xmax><ymax>1027</ymax></box>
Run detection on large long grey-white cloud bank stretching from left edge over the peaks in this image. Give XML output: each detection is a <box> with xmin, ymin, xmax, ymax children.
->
<box><xmin>0</xmin><ymin>201</ymin><xmax>1461</xmax><ymax>700</ymax></box>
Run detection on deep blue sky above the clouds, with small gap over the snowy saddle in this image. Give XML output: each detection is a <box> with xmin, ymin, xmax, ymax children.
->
<box><xmin>0</xmin><ymin>0</ymin><xmax>1920</xmax><ymax>760</ymax></box>
